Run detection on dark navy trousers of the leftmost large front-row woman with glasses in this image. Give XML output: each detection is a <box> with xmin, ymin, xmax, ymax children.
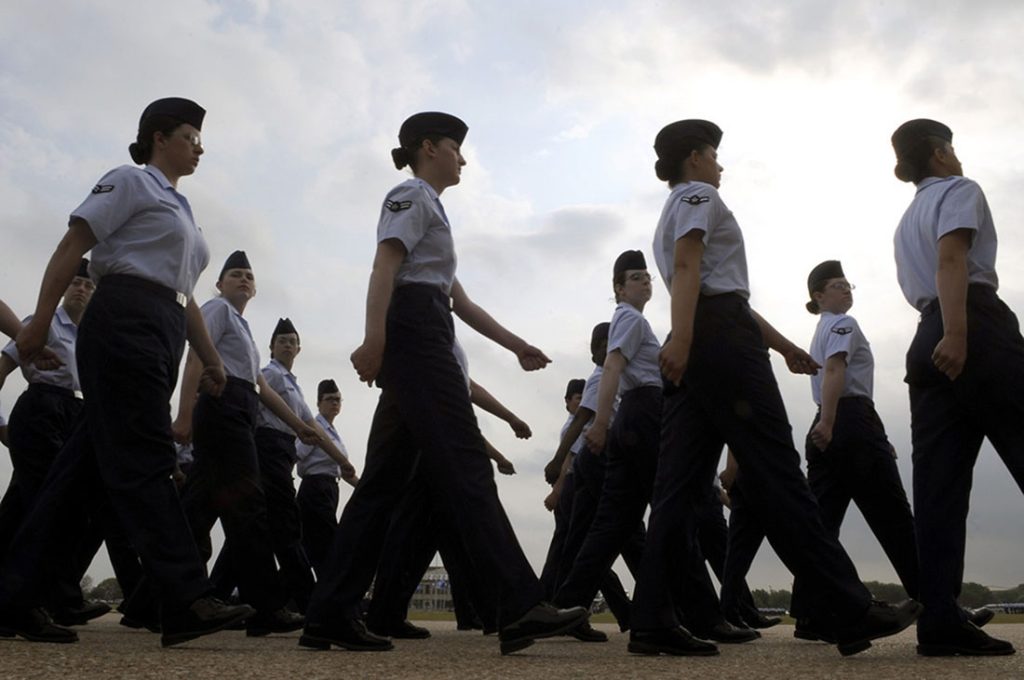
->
<box><xmin>0</xmin><ymin>277</ymin><xmax>210</xmax><ymax>611</ymax></box>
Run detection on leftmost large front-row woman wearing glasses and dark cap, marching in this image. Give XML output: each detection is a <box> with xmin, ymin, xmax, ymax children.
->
<box><xmin>0</xmin><ymin>97</ymin><xmax>253</xmax><ymax>645</ymax></box>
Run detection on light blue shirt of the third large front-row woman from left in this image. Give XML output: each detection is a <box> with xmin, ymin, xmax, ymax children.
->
<box><xmin>653</xmin><ymin>181</ymin><xmax>751</xmax><ymax>298</ymax></box>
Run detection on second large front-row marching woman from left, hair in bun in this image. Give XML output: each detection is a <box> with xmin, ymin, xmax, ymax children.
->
<box><xmin>300</xmin><ymin>113</ymin><xmax>587</xmax><ymax>653</ymax></box>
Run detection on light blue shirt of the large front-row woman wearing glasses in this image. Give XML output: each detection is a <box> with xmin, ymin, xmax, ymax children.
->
<box><xmin>71</xmin><ymin>165</ymin><xmax>210</xmax><ymax>298</ymax></box>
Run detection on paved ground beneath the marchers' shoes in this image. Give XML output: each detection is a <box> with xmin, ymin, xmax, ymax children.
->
<box><xmin>0</xmin><ymin>614</ymin><xmax>1024</xmax><ymax>680</ymax></box>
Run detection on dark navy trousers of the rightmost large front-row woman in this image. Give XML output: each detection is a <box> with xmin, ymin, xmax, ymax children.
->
<box><xmin>906</xmin><ymin>285</ymin><xmax>1024</xmax><ymax>640</ymax></box>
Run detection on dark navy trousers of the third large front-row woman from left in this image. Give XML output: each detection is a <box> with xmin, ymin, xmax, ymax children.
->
<box><xmin>633</xmin><ymin>294</ymin><xmax>870</xmax><ymax>630</ymax></box>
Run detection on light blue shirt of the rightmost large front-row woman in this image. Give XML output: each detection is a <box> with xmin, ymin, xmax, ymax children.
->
<box><xmin>894</xmin><ymin>176</ymin><xmax>999</xmax><ymax>311</ymax></box>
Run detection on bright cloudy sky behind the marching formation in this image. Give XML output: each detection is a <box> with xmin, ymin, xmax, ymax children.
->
<box><xmin>0</xmin><ymin>0</ymin><xmax>1024</xmax><ymax>587</ymax></box>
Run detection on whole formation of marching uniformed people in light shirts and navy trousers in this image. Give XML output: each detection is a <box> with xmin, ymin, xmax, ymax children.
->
<box><xmin>0</xmin><ymin>97</ymin><xmax>1024</xmax><ymax>655</ymax></box>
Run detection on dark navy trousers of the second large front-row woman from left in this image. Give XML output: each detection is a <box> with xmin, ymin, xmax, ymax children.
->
<box><xmin>307</xmin><ymin>285</ymin><xmax>544</xmax><ymax>626</ymax></box>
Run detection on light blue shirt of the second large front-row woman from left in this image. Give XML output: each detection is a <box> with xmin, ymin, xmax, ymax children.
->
<box><xmin>377</xmin><ymin>177</ymin><xmax>457</xmax><ymax>295</ymax></box>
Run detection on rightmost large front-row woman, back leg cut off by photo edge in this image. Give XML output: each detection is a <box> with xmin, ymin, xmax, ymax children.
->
<box><xmin>892</xmin><ymin>119</ymin><xmax>1024</xmax><ymax>656</ymax></box>
